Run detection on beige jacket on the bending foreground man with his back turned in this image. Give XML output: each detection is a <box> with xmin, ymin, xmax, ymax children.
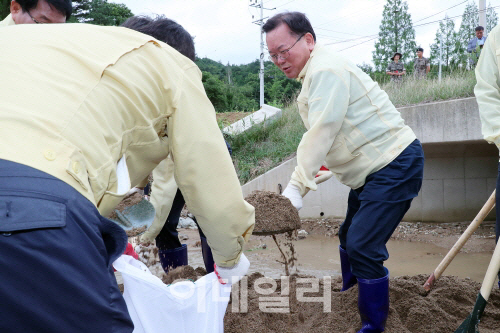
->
<box><xmin>0</xmin><ymin>24</ymin><xmax>254</xmax><ymax>267</ymax></box>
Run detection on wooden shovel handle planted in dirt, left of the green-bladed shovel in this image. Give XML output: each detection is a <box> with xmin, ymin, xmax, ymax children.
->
<box><xmin>424</xmin><ymin>190</ymin><xmax>496</xmax><ymax>291</ymax></box>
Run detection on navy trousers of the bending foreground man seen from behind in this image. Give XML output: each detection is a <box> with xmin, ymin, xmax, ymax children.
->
<box><xmin>0</xmin><ymin>160</ymin><xmax>133</xmax><ymax>333</ymax></box>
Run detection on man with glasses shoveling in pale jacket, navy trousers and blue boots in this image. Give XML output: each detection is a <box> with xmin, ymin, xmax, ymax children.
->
<box><xmin>262</xmin><ymin>12</ymin><xmax>424</xmax><ymax>333</ymax></box>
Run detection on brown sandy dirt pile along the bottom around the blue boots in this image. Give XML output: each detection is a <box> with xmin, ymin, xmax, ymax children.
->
<box><xmin>224</xmin><ymin>273</ymin><xmax>500</xmax><ymax>333</ymax></box>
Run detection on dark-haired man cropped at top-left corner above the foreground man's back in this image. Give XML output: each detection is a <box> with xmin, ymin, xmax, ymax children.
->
<box><xmin>0</xmin><ymin>0</ymin><xmax>73</xmax><ymax>27</ymax></box>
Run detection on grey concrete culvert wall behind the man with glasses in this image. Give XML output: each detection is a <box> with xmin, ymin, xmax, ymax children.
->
<box><xmin>242</xmin><ymin>98</ymin><xmax>499</xmax><ymax>222</ymax></box>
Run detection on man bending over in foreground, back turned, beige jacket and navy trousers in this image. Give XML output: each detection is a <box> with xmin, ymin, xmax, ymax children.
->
<box><xmin>0</xmin><ymin>24</ymin><xmax>254</xmax><ymax>332</ymax></box>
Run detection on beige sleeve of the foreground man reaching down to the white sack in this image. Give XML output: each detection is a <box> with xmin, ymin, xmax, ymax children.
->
<box><xmin>167</xmin><ymin>66</ymin><xmax>255</xmax><ymax>267</ymax></box>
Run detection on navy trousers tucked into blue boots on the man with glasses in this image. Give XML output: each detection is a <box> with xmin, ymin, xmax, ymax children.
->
<box><xmin>339</xmin><ymin>140</ymin><xmax>424</xmax><ymax>279</ymax></box>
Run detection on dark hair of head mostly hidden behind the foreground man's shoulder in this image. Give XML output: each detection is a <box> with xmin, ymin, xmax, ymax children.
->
<box><xmin>121</xmin><ymin>15</ymin><xmax>196</xmax><ymax>61</ymax></box>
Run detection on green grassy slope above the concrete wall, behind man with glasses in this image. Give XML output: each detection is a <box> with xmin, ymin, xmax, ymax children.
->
<box><xmin>228</xmin><ymin>71</ymin><xmax>476</xmax><ymax>184</ymax></box>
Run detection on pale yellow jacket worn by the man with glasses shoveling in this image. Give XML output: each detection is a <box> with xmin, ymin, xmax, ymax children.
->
<box><xmin>290</xmin><ymin>45</ymin><xmax>416</xmax><ymax>196</ymax></box>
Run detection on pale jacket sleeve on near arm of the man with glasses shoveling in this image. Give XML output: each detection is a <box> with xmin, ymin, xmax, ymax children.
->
<box><xmin>290</xmin><ymin>70</ymin><xmax>349</xmax><ymax>196</ymax></box>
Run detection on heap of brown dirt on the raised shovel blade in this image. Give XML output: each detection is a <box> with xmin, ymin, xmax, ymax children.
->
<box><xmin>245</xmin><ymin>191</ymin><xmax>300</xmax><ymax>235</ymax></box>
